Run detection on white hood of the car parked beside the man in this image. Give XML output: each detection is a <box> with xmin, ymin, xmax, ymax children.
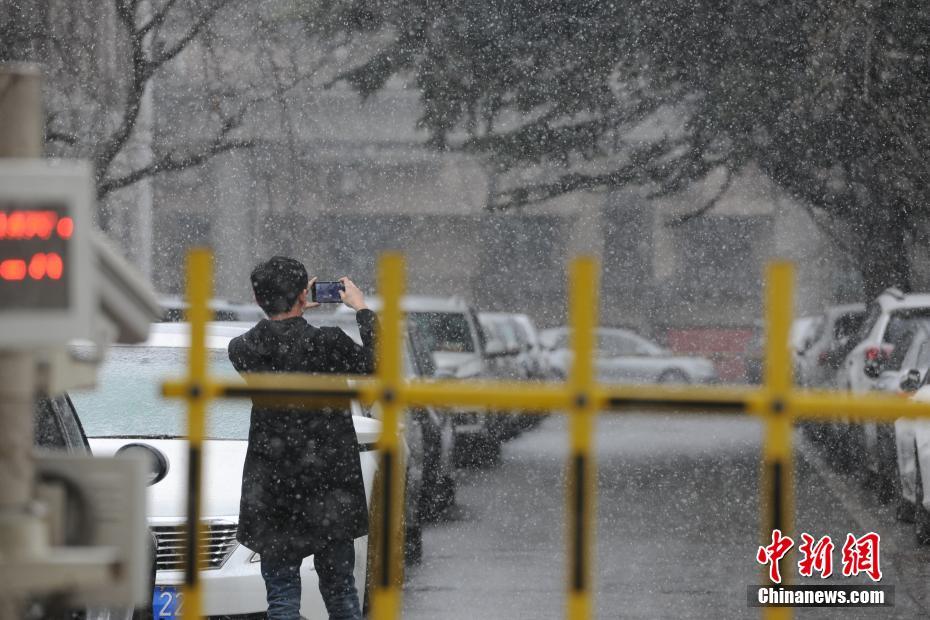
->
<box><xmin>89</xmin><ymin>416</ymin><xmax>381</xmax><ymax>521</ymax></box>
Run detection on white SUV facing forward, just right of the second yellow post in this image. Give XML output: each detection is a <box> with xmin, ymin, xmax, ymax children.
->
<box><xmin>336</xmin><ymin>295</ymin><xmax>508</xmax><ymax>465</ymax></box>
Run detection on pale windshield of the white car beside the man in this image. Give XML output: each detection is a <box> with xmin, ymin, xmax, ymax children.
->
<box><xmin>70</xmin><ymin>347</ymin><xmax>251</xmax><ymax>440</ymax></box>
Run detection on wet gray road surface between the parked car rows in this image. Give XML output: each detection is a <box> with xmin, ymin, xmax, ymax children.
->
<box><xmin>404</xmin><ymin>415</ymin><xmax>930</xmax><ymax>620</ymax></box>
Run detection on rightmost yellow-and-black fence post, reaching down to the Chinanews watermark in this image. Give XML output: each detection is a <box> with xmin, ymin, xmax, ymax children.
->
<box><xmin>760</xmin><ymin>262</ymin><xmax>794</xmax><ymax>620</ymax></box>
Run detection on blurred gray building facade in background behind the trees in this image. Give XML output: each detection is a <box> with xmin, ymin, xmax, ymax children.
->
<box><xmin>9</xmin><ymin>0</ymin><xmax>864</xmax><ymax>378</ymax></box>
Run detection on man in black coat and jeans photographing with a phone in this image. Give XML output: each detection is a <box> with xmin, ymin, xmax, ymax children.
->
<box><xmin>229</xmin><ymin>256</ymin><xmax>376</xmax><ymax>620</ymax></box>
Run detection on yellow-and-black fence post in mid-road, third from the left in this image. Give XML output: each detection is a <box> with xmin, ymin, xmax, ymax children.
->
<box><xmin>565</xmin><ymin>258</ymin><xmax>598</xmax><ymax>620</ymax></box>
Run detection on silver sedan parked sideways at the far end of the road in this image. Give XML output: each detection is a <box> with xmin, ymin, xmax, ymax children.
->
<box><xmin>541</xmin><ymin>327</ymin><xmax>717</xmax><ymax>383</ymax></box>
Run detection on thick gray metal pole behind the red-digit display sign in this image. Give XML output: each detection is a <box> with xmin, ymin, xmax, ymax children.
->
<box><xmin>0</xmin><ymin>64</ymin><xmax>45</xmax><ymax>620</ymax></box>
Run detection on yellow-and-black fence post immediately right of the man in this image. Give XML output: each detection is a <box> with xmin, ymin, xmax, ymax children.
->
<box><xmin>371</xmin><ymin>254</ymin><xmax>404</xmax><ymax>620</ymax></box>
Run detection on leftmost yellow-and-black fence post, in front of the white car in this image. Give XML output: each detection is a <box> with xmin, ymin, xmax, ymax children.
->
<box><xmin>182</xmin><ymin>248</ymin><xmax>213</xmax><ymax>620</ymax></box>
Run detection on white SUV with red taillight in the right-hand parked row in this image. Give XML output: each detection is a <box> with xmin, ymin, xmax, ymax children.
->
<box><xmin>832</xmin><ymin>289</ymin><xmax>930</xmax><ymax>469</ymax></box>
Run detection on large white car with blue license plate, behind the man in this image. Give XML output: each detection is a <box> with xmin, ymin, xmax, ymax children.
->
<box><xmin>70</xmin><ymin>323</ymin><xmax>381</xmax><ymax>618</ymax></box>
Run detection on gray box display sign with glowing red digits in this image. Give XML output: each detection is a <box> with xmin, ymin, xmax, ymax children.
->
<box><xmin>0</xmin><ymin>159</ymin><xmax>97</xmax><ymax>347</ymax></box>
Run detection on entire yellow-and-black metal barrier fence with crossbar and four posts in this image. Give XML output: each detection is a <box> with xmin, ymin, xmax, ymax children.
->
<box><xmin>163</xmin><ymin>250</ymin><xmax>930</xmax><ymax>620</ymax></box>
